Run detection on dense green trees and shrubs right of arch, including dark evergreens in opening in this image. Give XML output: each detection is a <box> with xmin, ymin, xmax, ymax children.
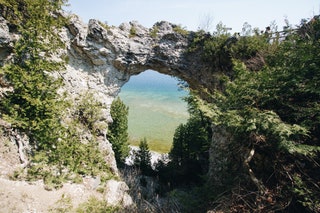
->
<box><xmin>136</xmin><ymin>17</ymin><xmax>320</xmax><ymax>212</ymax></box>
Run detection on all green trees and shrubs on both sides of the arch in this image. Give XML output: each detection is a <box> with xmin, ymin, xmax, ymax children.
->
<box><xmin>0</xmin><ymin>0</ymin><xmax>320</xmax><ymax>212</ymax></box>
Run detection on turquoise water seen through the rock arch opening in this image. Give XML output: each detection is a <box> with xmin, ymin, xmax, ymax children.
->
<box><xmin>119</xmin><ymin>70</ymin><xmax>189</xmax><ymax>152</ymax></box>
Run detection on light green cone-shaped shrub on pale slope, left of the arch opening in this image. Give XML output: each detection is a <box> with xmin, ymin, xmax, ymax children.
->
<box><xmin>38</xmin><ymin>93</ymin><xmax>113</xmax><ymax>185</ymax></box>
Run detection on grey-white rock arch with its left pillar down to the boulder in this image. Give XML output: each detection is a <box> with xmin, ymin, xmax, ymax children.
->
<box><xmin>0</xmin><ymin>9</ymin><xmax>226</xmax><ymax>210</ymax></box>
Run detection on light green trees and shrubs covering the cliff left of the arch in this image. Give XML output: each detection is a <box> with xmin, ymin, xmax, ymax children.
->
<box><xmin>0</xmin><ymin>0</ymin><xmax>112</xmax><ymax>188</ymax></box>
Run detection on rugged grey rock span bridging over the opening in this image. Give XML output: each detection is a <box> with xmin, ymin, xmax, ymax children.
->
<box><xmin>65</xmin><ymin>16</ymin><xmax>220</xmax><ymax>97</ymax></box>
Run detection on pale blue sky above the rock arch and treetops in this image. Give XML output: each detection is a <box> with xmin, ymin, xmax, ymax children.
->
<box><xmin>66</xmin><ymin>0</ymin><xmax>320</xmax><ymax>32</ymax></box>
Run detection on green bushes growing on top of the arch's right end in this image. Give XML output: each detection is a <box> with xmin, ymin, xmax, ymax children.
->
<box><xmin>188</xmin><ymin>22</ymin><xmax>273</xmax><ymax>75</ymax></box>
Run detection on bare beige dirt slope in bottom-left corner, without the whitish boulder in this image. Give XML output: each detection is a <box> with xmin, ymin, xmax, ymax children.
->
<box><xmin>0</xmin><ymin>134</ymin><xmax>102</xmax><ymax>213</ymax></box>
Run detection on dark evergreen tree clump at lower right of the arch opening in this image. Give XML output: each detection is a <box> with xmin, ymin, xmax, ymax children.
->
<box><xmin>168</xmin><ymin>118</ymin><xmax>211</xmax><ymax>186</ymax></box>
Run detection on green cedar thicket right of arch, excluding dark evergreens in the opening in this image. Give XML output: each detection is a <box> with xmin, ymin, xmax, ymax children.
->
<box><xmin>188</xmin><ymin>17</ymin><xmax>320</xmax><ymax>212</ymax></box>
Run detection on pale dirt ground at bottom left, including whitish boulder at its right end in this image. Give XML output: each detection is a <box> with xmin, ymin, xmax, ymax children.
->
<box><xmin>0</xmin><ymin>125</ymin><xmax>132</xmax><ymax>213</ymax></box>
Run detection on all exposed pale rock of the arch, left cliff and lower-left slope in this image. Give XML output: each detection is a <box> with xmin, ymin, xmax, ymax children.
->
<box><xmin>0</xmin><ymin>9</ymin><xmax>229</xmax><ymax>211</ymax></box>
